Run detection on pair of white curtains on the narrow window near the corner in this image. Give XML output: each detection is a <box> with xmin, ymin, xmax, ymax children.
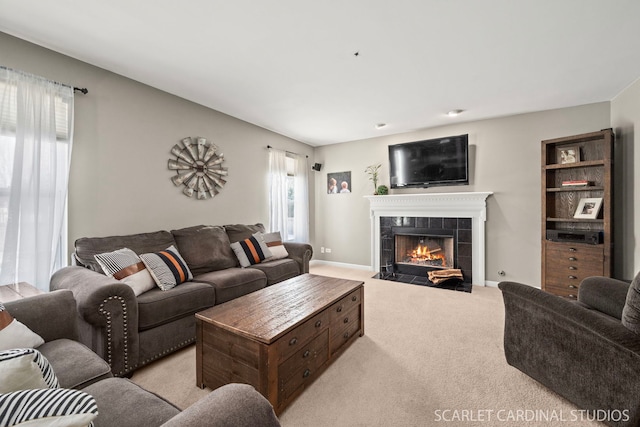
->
<box><xmin>269</xmin><ymin>148</ymin><xmax>309</xmax><ymax>242</ymax></box>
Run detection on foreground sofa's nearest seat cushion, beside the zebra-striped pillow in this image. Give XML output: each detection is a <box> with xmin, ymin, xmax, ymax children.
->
<box><xmin>83</xmin><ymin>378</ymin><xmax>180</xmax><ymax>427</ymax></box>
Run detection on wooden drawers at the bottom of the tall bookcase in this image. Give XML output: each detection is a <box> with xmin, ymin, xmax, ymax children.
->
<box><xmin>543</xmin><ymin>241</ymin><xmax>604</xmax><ymax>299</ymax></box>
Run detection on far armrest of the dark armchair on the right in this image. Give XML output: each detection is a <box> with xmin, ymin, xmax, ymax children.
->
<box><xmin>578</xmin><ymin>276</ymin><xmax>629</xmax><ymax>319</ymax></box>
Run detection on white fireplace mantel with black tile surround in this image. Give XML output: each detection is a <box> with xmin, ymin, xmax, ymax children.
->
<box><xmin>365</xmin><ymin>192</ymin><xmax>493</xmax><ymax>286</ymax></box>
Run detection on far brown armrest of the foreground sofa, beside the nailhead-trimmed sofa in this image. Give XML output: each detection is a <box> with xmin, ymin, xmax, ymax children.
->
<box><xmin>4</xmin><ymin>290</ymin><xmax>78</xmax><ymax>342</ymax></box>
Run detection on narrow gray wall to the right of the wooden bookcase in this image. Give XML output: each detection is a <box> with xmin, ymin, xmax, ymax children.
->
<box><xmin>611</xmin><ymin>76</ymin><xmax>640</xmax><ymax>279</ymax></box>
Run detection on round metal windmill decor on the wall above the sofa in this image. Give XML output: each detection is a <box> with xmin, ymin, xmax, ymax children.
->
<box><xmin>169</xmin><ymin>137</ymin><xmax>228</xmax><ymax>200</ymax></box>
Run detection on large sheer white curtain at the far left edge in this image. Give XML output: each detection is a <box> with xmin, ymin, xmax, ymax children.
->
<box><xmin>0</xmin><ymin>68</ymin><xmax>73</xmax><ymax>291</ymax></box>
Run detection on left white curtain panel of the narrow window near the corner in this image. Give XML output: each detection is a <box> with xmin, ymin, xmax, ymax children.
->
<box><xmin>269</xmin><ymin>148</ymin><xmax>288</xmax><ymax>240</ymax></box>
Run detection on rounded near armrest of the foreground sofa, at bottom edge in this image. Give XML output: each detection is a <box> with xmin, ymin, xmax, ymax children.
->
<box><xmin>162</xmin><ymin>384</ymin><xmax>280</xmax><ymax>427</ymax></box>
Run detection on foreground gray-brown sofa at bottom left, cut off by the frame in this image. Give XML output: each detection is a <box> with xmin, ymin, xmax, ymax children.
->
<box><xmin>5</xmin><ymin>291</ymin><xmax>280</xmax><ymax>427</ymax></box>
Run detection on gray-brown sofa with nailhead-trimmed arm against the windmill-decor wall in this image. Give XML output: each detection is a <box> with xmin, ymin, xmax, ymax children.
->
<box><xmin>50</xmin><ymin>224</ymin><xmax>313</xmax><ymax>376</ymax></box>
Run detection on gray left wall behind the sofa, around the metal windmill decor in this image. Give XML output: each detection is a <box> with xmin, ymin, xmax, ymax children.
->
<box><xmin>0</xmin><ymin>33</ymin><xmax>313</xmax><ymax>258</ymax></box>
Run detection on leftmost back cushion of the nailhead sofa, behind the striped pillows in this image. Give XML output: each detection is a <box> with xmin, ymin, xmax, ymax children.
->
<box><xmin>75</xmin><ymin>230</ymin><xmax>176</xmax><ymax>273</ymax></box>
